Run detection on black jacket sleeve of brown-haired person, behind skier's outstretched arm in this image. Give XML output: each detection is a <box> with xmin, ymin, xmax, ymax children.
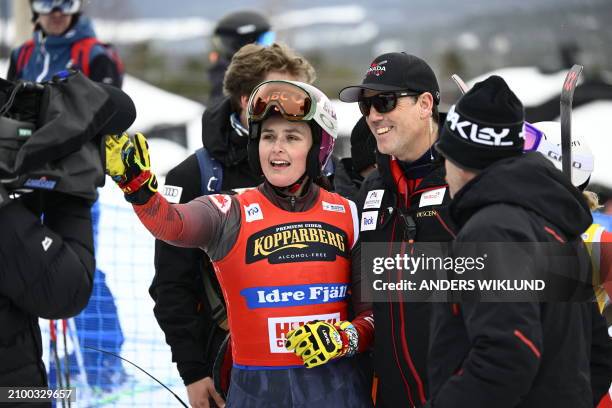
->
<box><xmin>149</xmin><ymin>155</ymin><xmax>225</xmax><ymax>385</ymax></box>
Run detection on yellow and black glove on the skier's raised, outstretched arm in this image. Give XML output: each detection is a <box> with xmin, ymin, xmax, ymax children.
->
<box><xmin>105</xmin><ymin>133</ymin><xmax>157</xmax><ymax>205</ymax></box>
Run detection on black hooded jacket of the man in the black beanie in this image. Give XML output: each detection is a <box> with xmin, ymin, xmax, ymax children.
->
<box><xmin>426</xmin><ymin>153</ymin><xmax>612</xmax><ymax>408</ymax></box>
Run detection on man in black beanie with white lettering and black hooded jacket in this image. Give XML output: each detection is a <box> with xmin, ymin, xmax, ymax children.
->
<box><xmin>428</xmin><ymin>76</ymin><xmax>610</xmax><ymax>408</ymax></box>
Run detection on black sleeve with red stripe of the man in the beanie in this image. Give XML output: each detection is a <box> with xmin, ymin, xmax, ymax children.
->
<box><xmin>430</xmin><ymin>218</ymin><xmax>543</xmax><ymax>408</ymax></box>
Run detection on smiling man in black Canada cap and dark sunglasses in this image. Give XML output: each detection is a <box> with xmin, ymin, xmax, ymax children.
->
<box><xmin>340</xmin><ymin>52</ymin><xmax>453</xmax><ymax>407</ymax></box>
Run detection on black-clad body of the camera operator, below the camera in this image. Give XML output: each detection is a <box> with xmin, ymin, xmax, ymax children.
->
<box><xmin>0</xmin><ymin>184</ymin><xmax>95</xmax><ymax>387</ymax></box>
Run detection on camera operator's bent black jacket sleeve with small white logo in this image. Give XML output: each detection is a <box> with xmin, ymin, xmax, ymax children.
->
<box><xmin>0</xmin><ymin>194</ymin><xmax>95</xmax><ymax>319</ymax></box>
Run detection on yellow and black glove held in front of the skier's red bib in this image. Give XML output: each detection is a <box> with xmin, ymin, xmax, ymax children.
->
<box><xmin>285</xmin><ymin>320</ymin><xmax>359</xmax><ymax>368</ymax></box>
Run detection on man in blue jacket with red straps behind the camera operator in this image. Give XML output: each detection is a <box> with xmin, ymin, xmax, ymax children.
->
<box><xmin>7</xmin><ymin>0</ymin><xmax>126</xmax><ymax>387</ymax></box>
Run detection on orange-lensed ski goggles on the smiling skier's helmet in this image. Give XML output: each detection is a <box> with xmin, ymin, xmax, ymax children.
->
<box><xmin>248</xmin><ymin>81</ymin><xmax>317</xmax><ymax>121</ymax></box>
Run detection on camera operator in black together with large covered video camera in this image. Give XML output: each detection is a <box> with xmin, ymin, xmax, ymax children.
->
<box><xmin>0</xmin><ymin>71</ymin><xmax>136</xmax><ymax>398</ymax></box>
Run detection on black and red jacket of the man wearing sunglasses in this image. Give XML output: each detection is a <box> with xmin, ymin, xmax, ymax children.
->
<box><xmin>357</xmin><ymin>149</ymin><xmax>454</xmax><ymax>407</ymax></box>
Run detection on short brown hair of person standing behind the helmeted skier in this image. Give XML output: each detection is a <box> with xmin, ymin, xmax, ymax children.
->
<box><xmin>223</xmin><ymin>43</ymin><xmax>316</xmax><ymax>110</ymax></box>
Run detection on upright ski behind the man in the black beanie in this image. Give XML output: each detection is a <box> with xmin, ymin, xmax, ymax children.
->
<box><xmin>560</xmin><ymin>64</ymin><xmax>584</xmax><ymax>180</ymax></box>
